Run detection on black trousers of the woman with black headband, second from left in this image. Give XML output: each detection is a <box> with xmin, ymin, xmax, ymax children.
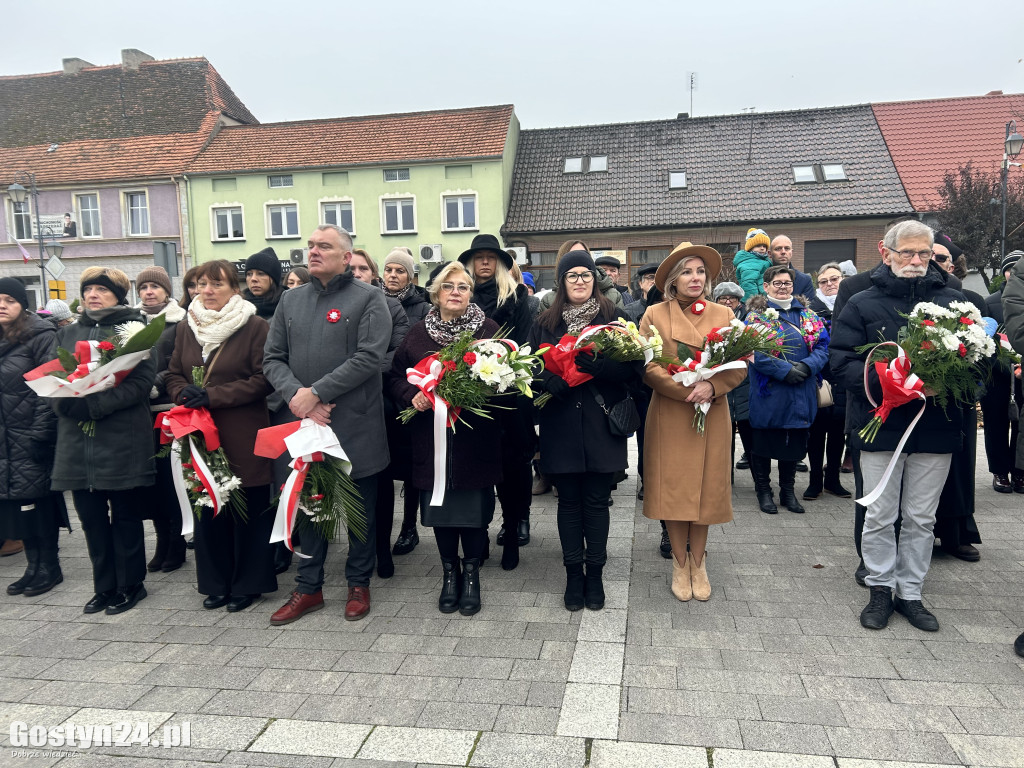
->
<box><xmin>72</xmin><ymin>486</ymin><xmax>151</xmax><ymax>592</ymax></box>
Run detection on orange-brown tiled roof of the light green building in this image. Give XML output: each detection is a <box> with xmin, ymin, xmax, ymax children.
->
<box><xmin>188</xmin><ymin>104</ymin><xmax>513</xmax><ymax>173</ymax></box>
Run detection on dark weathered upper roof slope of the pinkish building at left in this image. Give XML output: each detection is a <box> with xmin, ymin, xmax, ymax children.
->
<box><xmin>0</xmin><ymin>58</ymin><xmax>258</xmax><ymax>146</ymax></box>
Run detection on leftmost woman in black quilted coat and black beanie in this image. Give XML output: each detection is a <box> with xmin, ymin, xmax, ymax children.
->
<box><xmin>0</xmin><ymin>278</ymin><xmax>68</xmax><ymax>597</ymax></box>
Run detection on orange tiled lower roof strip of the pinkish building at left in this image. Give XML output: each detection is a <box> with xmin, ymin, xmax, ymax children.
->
<box><xmin>0</xmin><ymin>112</ymin><xmax>218</xmax><ymax>184</ymax></box>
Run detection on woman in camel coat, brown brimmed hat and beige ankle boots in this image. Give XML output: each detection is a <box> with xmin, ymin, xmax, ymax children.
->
<box><xmin>640</xmin><ymin>243</ymin><xmax>746</xmax><ymax>600</ymax></box>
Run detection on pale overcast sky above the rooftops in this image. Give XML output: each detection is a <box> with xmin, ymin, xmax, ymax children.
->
<box><xmin>0</xmin><ymin>0</ymin><xmax>1024</xmax><ymax>128</ymax></box>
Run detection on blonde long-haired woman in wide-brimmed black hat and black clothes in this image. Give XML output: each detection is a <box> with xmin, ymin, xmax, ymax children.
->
<box><xmin>459</xmin><ymin>234</ymin><xmax>537</xmax><ymax>570</ymax></box>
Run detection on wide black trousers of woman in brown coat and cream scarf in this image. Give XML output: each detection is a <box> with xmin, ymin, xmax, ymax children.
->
<box><xmin>196</xmin><ymin>485</ymin><xmax>278</xmax><ymax>595</ymax></box>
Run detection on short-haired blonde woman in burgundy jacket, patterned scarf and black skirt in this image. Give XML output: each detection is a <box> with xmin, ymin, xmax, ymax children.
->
<box><xmin>388</xmin><ymin>262</ymin><xmax>505</xmax><ymax>616</ymax></box>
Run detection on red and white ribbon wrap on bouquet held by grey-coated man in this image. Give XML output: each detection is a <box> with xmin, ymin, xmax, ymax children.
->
<box><xmin>253</xmin><ymin>419</ymin><xmax>352</xmax><ymax>557</ymax></box>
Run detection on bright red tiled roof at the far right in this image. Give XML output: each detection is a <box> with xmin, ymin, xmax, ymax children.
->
<box><xmin>871</xmin><ymin>93</ymin><xmax>1024</xmax><ymax>211</ymax></box>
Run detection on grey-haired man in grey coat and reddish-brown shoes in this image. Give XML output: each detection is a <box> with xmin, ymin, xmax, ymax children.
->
<box><xmin>263</xmin><ymin>224</ymin><xmax>391</xmax><ymax>625</ymax></box>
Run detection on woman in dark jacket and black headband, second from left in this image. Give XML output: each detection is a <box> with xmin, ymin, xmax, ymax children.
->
<box><xmin>50</xmin><ymin>266</ymin><xmax>157</xmax><ymax>614</ymax></box>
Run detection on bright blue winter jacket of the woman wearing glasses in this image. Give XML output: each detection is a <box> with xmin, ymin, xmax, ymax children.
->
<box><xmin>746</xmin><ymin>297</ymin><xmax>828</xmax><ymax>429</ymax></box>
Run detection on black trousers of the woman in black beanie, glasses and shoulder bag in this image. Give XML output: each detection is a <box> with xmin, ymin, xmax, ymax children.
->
<box><xmin>549</xmin><ymin>472</ymin><xmax>614</xmax><ymax>565</ymax></box>
